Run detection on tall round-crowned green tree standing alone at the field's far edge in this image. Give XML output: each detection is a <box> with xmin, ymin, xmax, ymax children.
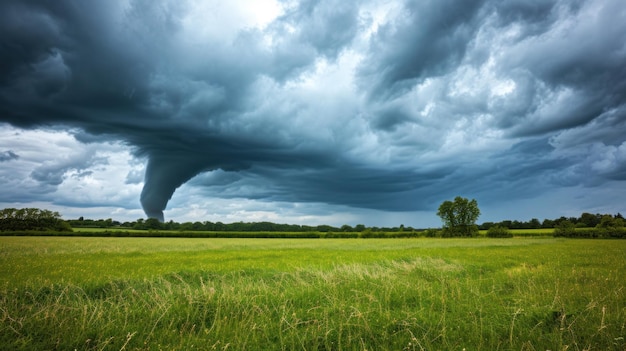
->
<box><xmin>437</xmin><ymin>196</ymin><xmax>480</xmax><ymax>237</ymax></box>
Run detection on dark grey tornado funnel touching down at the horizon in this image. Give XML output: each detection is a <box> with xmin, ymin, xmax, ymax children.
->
<box><xmin>140</xmin><ymin>155</ymin><xmax>204</xmax><ymax>222</ymax></box>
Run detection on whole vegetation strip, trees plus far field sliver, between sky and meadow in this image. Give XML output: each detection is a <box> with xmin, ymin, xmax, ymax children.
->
<box><xmin>0</xmin><ymin>208</ymin><xmax>626</xmax><ymax>239</ymax></box>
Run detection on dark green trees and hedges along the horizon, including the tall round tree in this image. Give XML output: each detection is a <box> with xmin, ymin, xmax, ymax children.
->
<box><xmin>0</xmin><ymin>206</ymin><xmax>626</xmax><ymax>237</ymax></box>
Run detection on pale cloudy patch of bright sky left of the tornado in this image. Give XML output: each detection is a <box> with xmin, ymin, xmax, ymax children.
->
<box><xmin>0</xmin><ymin>125</ymin><xmax>145</xmax><ymax>220</ymax></box>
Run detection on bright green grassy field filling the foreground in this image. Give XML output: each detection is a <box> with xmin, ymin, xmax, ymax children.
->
<box><xmin>0</xmin><ymin>237</ymin><xmax>626</xmax><ymax>351</ymax></box>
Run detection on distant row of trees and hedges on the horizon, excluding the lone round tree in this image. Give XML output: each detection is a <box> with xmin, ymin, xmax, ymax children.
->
<box><xmin>0</xmin><ymin>208</ymin><xmax>626</xmax><ymax>239</ymax></box>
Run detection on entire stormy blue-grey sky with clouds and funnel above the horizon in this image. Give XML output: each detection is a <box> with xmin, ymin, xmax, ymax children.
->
<box><xmin>0</xmin><ymin>0</ymin><xmax>626</xmax><ymax>228</ymax></box>
